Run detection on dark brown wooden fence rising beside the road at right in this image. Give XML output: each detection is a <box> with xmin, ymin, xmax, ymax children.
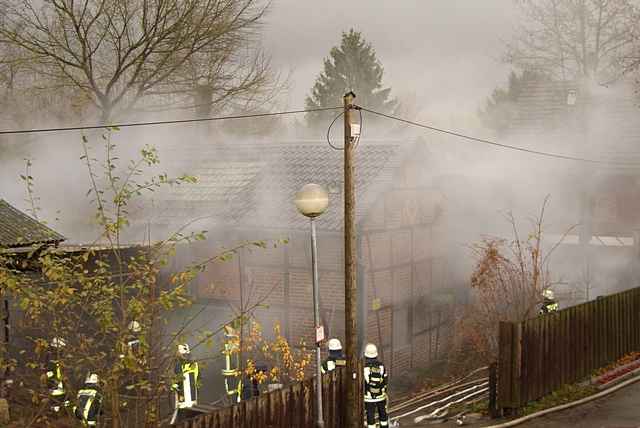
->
<box><xmin>498</xmin><ymin>288</ymin><xmax>640</xmax><ymax>409</ymax></box>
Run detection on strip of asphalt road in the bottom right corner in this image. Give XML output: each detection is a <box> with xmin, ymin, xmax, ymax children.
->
<box><xmin>518</xmin><ymin>382</ymin><xmax>640</xmax><ymax>428</ymax></box>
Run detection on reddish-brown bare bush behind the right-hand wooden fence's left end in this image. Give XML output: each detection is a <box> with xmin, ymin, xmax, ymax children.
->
<box><xmin>452</xmin><ymin>199</ymin><xmax>559</xmax><ymax>369</ymax></box>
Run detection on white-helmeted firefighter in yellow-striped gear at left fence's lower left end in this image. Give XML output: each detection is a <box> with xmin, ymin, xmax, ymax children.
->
<box><xmin>171</xmin><ymin>343</ymin><xmax>199</xmax><ymax>425</ymax></box>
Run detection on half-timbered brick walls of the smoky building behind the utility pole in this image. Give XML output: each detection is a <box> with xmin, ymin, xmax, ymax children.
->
<box><xmin>170</xmin><ymin>150</ymin><xmax>452</xmax><ymax>382</ymax></box>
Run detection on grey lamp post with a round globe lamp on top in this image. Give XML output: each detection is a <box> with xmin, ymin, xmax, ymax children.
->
<box><xmin>295</xmin><ymin>184</ymin><xmax>329</xmax><ymax>428</ymax></box>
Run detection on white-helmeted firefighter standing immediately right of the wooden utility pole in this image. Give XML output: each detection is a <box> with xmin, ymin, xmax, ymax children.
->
<box><xmin>364</xmin><ymin>343</ymin><xmax>389</xmax><ymax>428</ymax></box>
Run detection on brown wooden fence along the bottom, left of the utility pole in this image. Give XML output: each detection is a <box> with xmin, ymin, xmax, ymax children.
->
<box><xmin>179</xmin><ymin>368</ymin><xmax>364</xmax><ymax>428</ymax></box>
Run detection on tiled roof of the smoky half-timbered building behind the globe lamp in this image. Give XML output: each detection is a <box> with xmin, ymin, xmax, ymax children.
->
<box><xmin>151</xmin><ymin>141</ymin><xmax>416</xmax><ymax>231</ymax></box>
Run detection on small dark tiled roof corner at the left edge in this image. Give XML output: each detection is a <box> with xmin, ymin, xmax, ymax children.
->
<box><xmin>0</xmin><ymin>199</ymin><xmax>65</xmax><ymax>248</ymax></box>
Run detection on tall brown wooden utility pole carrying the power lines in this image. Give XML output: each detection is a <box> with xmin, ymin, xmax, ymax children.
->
<box><xmin>343</xmin><ymin>92</ymin><xmax>363</xmax><ymax>428</ymax></box>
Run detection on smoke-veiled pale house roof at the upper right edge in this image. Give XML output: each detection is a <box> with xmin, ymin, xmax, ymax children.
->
<box><xmin>509</xmin><ymin>80</ymin><xmax>640</xmax><ymax>174</ymax></box>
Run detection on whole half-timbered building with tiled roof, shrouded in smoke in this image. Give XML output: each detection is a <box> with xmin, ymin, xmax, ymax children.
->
<box><xmin>153</xmin><ymin>141</ymin><xmax>456</xmax><ymax>382</ymax></box>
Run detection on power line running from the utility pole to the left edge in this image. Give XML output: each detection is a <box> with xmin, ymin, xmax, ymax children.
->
<box><xmin>0</xmin><ymin>107</ymin><xmax>343</xmax><ymax>135</ymax></box>
